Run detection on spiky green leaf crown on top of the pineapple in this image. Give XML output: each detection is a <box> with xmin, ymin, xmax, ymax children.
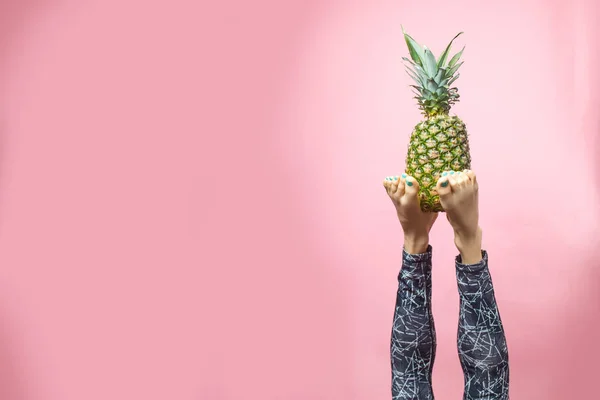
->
<box><xmin>402</xmin><ymin>27</ymin><xmax>465</xmax><ymax>116</ymax></box>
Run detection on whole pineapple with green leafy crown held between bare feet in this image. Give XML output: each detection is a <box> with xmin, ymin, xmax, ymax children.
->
<box><xmin>402</xmin><ymin>28</ymin><xmax>471</xmax><ymax>212</ymax></box>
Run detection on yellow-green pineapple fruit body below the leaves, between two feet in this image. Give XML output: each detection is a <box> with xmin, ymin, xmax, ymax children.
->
<box><xmin>406</xmin><ymin>114</ymin><xmax>471</xmax><ymax>212</ymax></box>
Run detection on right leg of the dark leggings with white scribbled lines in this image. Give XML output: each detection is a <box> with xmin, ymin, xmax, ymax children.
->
<box><xmin>456</xmin><ymin>251</ymin><xmax>509</xmax><ymax>400</ymax></box>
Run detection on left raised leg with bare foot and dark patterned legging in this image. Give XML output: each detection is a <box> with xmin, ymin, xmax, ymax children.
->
<box><xmin>384</xmin><ymin>174</ymin><xmax>437</xmax><ymax>400</ymax></box>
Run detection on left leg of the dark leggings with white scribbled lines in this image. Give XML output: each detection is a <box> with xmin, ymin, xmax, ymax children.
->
<box><xmin>391</xmin><ymin>246</ymin><xmax>436</xmax><ymax>400</ymax></box>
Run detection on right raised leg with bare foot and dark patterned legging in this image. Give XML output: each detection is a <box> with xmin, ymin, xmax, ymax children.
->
<box><xmin>437</xmin><ymin>171</ymin><xmax>509</xmax><ymax>400</ymax></box>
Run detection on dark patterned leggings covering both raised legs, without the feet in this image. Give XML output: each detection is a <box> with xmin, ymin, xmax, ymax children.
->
<box><xmin>391</xmin><ymin>246</ymin><xmax>509</xmax><ymax>400</ymax></box>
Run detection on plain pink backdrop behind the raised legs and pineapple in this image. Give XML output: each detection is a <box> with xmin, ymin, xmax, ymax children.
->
<box><xmin>0</xmin><ymin>0</ymin><xmax>600</xmax><ymax>400</ymax></box>
